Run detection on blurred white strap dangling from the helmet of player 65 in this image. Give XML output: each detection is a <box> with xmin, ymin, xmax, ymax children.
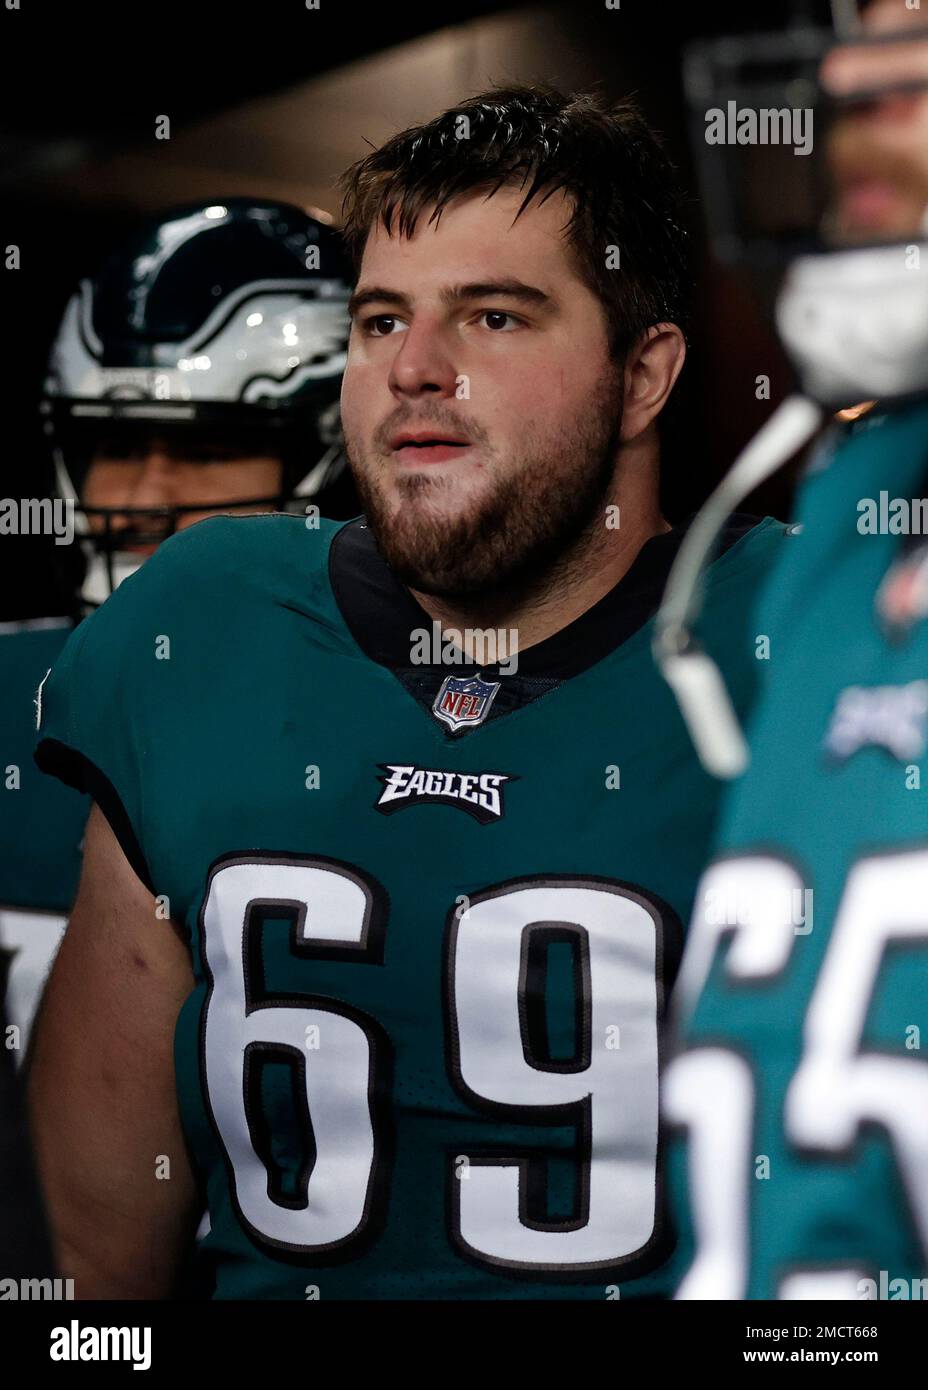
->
<box><xmin>653</xmin><ymin>395</ymin><xmax>825</xmax><ymax>778</ymax></box>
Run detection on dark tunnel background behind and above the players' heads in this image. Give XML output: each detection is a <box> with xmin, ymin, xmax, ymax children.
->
<box><xmin>0</xmin><ymin>0</ymin><xmax>813</xmax><ymax>619</ymax></box>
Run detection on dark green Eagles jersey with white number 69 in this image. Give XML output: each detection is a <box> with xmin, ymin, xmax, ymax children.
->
<box><xmin>30</xmin><ymin>514</ymin><xmax>789</xmax><ymax>1298</ymax></box>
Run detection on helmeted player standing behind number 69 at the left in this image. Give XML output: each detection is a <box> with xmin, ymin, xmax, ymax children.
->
<box><xmin>0</xmin><ymin>197</ymin><xmax>351</xmax><ymax>1059</ymax></box>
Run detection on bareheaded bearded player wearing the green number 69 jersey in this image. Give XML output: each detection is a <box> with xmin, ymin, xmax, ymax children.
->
<box><xmin>31</xmin><ymin>86</ymin><xmax>789</xmax><ymax>1300</ymax></box>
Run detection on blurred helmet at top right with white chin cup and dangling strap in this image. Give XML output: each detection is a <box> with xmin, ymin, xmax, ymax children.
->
<box><xmin>653</xmin><ymin>0</ymin><xmax>928</xmax><ymax>777</ymax></box>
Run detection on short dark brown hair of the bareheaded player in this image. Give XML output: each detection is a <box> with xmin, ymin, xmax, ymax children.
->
<box><xmin>340</xmin><ymin>83</ymin><xmax>690</xmax><ymax>357</ymax></box>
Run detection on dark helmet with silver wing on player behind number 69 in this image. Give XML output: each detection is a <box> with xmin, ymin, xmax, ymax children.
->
<box><xmin>42</xmin><ymin>197</ymin><xmax>356</xmax><ymax>603</ymax></box>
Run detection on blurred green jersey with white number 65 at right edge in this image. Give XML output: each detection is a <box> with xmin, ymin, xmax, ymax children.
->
<box><xmin>665</xmin><ymin>403</ymin><xmax>928</xmax><ymax>1298</ymax></box>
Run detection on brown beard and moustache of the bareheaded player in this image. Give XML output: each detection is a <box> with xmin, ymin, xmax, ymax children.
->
<box><xmin>347</xmin><ymin>364</ymin><xmax>622</xmax><ymax>599</ymax></box>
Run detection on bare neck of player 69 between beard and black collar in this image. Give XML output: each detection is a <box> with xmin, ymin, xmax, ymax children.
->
<box><xmin>410</xmin><ymin>447</ymin><xmax>670</xmax><ymax>662</ymax></box>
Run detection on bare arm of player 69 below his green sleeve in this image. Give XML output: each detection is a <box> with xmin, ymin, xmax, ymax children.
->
<box><xmin>28</xmin><ymin>806</ymin><xmax>200</xmax><ymax>1298</ymax></box>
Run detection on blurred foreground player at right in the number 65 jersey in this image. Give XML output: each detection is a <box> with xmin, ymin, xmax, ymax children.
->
<box><xmin>655</xmin><ymin>0</ymin><xmax>928</xmax><ymax>1300</ymax></box>
